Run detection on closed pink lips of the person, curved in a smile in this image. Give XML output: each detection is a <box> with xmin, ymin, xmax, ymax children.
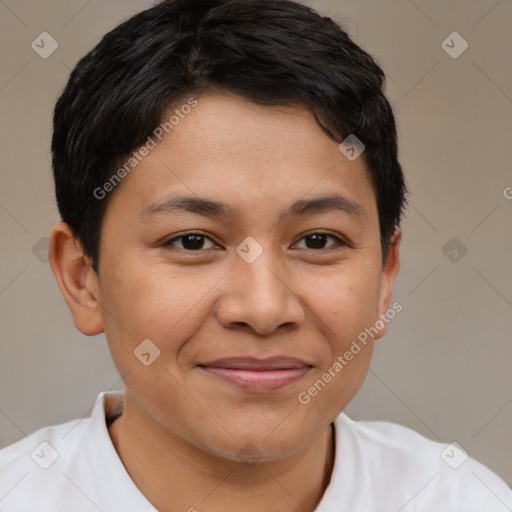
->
<box><xmin>198</xmin><ymin>357</ymin><xmax>312</xmax><ymax>392</ymax></box>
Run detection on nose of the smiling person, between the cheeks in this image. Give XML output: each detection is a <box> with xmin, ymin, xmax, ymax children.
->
<box><xmin>216</xmin><ymin>244</ymin><xmax>305</xmax><ymax>336</ymax></box>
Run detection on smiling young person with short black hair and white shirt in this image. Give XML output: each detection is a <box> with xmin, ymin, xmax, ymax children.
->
<box><xmin>0</xmin><ymin>0</ymin><xmax>512</xmax><ymax>512</ymax></box>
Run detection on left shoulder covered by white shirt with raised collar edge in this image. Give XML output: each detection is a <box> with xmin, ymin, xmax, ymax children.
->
<box><xmin>0</xmin><ymin>392</ymin><xmax>136</xmax><ymax>512</ymax></box>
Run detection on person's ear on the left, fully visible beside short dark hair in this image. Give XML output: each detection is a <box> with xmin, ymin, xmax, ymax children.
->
<box><xmin>50</xmin><ymin>222</ymin><xmax>103</xmax><ymax>336</ymax></box>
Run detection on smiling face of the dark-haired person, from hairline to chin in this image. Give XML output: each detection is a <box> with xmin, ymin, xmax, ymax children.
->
<box><xmin>86</xmin><ymin>93</ymin><xmax>398</xmax><ymax>460</ymax></box>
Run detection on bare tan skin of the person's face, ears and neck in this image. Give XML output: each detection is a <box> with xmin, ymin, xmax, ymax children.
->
<box><xmin>50</xmin><ymin>91</ymin><xmax>401</xmax><ymax>512</ymax></box>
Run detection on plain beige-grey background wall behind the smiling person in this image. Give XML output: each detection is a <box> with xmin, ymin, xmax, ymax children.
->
<box><xmin>0</xmin><ymin>0</ymin><xmax>512</xmax><ymax>484</ymax></box>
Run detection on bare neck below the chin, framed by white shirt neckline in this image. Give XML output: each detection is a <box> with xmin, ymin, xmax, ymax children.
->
<box><xmin>109</xmin><ymin>397</ymin><xmax>334</xmax><ymax>512</ymax></box>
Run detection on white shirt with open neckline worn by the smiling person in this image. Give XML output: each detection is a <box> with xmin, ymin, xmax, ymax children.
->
<box><xmin>0</xmin><ymin>391</ymin><xmax>512</xmax><ymax>512</ymax></box>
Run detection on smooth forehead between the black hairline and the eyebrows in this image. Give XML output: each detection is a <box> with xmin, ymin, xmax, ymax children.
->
<box><xmin>105</xmin><ymin>93</ymin><xmax>375</xmax><ymax>226</ymax></box>
